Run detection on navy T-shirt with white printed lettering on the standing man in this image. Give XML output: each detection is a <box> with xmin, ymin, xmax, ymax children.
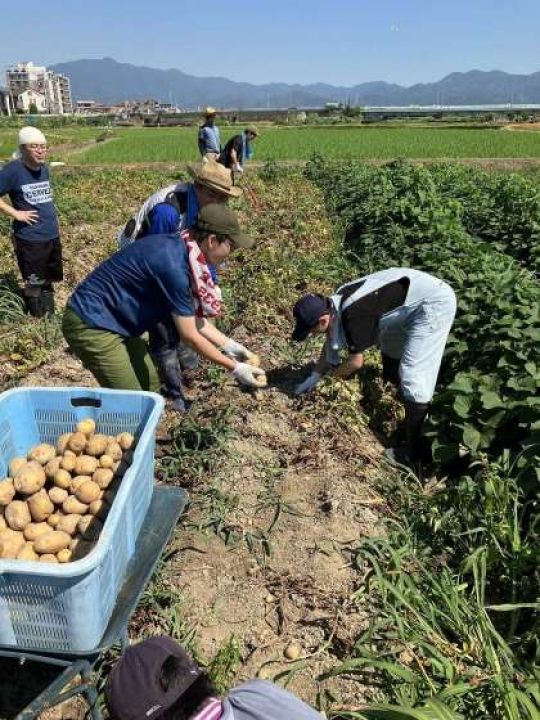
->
<box><xmin>0</xmin><ymin>160</ymin><xmax>59</xmax><ymax>242</ymax></box>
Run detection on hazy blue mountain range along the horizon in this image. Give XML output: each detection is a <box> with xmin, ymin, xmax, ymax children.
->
<box><xmin>51</xmin><ymin>58</ymin><xmax>540</xmax><ymax>109</ymax></box>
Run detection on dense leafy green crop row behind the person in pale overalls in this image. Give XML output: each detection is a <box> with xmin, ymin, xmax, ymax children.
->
<box><xmin>307</xmin><ymin>159</ymin><xmax>540</xmax><ymax>461</ymax></box>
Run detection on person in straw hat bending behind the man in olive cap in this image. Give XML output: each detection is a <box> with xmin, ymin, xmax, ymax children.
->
<box><xmin>118</xmin><ymin>162</ymin><xmax>247</xmax><ymax>412</ymax></box>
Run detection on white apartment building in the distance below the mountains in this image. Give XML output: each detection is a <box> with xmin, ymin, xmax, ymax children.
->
<box><xmin>6</xmin><ymin>62</ymin><xmax>73</xmax><ymax>115</ymax></box>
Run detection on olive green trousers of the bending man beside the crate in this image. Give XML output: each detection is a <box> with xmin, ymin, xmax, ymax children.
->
<box><xmin>62</xmin><ymin>305</ymin><xmax>160</xmax><ymax>392</ymax></box>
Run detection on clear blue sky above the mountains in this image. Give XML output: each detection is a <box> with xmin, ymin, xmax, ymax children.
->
<box><xmin>0</xmin><ymin>0</ymin><xmax>540</xmax><ymax>85</ymax></box>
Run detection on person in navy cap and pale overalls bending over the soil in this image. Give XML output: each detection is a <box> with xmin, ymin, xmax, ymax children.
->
<box><xmin>292</xmin><ymin>268</ymin><xmax>456</xmax><ymax>465</ymax></box>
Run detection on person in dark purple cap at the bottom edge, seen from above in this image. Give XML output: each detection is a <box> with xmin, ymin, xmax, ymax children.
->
<box><xmin>105</xmin><ymin>636</ymin><xmax>322</xmax><ymax>720</ymax></box>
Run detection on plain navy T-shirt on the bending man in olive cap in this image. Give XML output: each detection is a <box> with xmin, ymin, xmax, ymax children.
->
<box><xmin>69</xmin><ymin>234</ymin><xmax>195</xmax><ymax>337</ymax></box>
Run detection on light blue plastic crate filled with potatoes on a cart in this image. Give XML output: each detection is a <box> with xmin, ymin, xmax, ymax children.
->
<box><xmin>0</xmin><ymin>388</ymin><xmax>163</xmax><ymax>652</ymax></box>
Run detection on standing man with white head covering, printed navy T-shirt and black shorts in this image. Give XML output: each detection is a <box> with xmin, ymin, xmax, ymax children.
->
<box><xmin>0</xmin><ymin>126</ymin><xmax>63</xmax><ymax>317</ymax></box>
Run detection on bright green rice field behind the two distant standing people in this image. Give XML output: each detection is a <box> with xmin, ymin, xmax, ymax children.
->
<box><xmin>71</xmin><ymin>126</ymin><xmax>540</xmax><ymax>164</ymax></box>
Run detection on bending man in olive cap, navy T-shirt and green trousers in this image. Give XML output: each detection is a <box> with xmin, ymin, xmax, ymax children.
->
<box><xmin>62</xmin><ymin>204</ymin><xmax>264</xmax><ymax>392</ymax></box>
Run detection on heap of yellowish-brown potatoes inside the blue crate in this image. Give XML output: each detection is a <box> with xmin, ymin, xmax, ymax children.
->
<box><xmin>0</xmin><ymin>418</ymin><xmax>134</xmax><ymax>563</ymax></box>
